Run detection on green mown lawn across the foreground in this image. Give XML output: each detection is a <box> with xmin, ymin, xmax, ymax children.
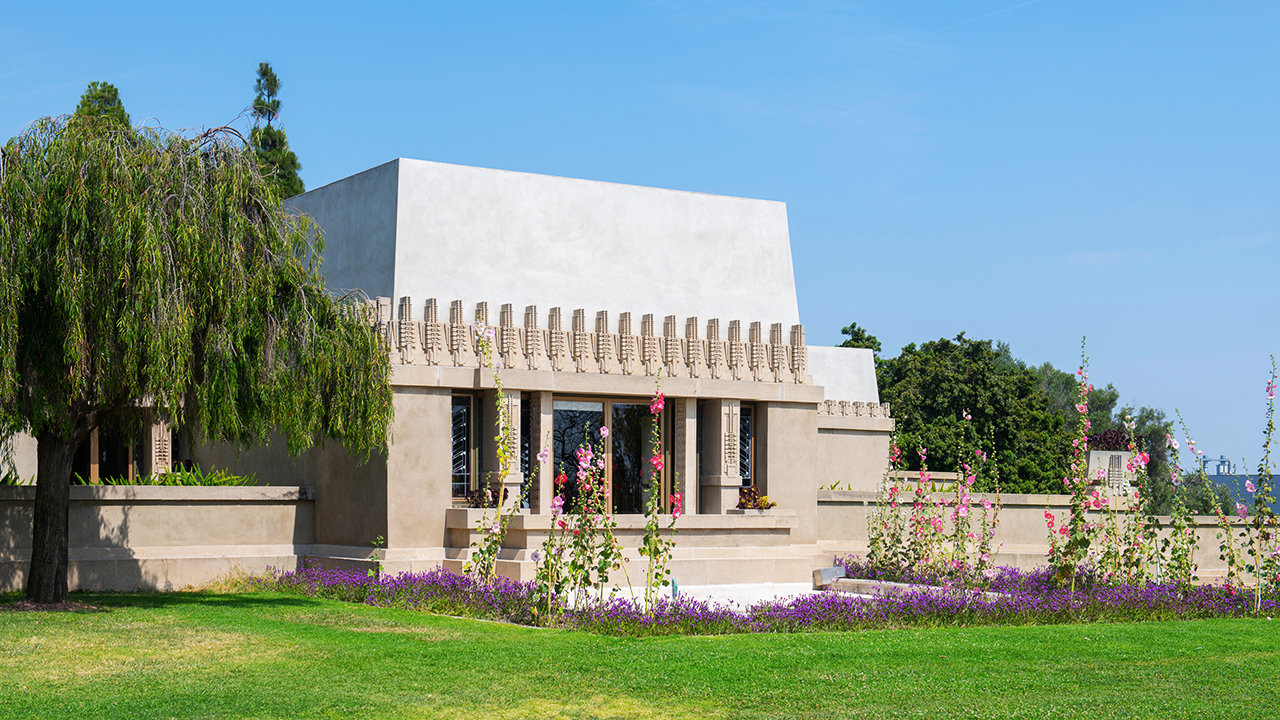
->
<box><xmin>0</xmin><ymin>593</ymin><xmax>1280</xmax><ymax>720</ymax></box>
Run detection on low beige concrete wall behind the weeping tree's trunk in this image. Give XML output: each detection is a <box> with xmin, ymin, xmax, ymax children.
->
<box><xmin>0</xmin><ymin>486</ymin><xmax>315</xmax><ymax>591</ymax></box>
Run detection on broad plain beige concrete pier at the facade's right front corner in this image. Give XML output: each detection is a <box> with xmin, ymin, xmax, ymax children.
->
<box><xmin>755</xmin><ymin>402</ymin><xmax>819</xmax><ymax>544</ymax></box>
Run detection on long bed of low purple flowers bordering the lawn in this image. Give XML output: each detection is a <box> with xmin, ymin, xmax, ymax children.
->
<box><xmin>259</xmin><ymin>559</ymin><xmax>1280</xmax><ymax>635</ymax></box>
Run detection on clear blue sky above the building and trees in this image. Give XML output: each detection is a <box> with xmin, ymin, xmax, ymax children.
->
<box><xmin>0</xmin><ymin>0</ymin><xmax>1280</xmax><ymax>474</ymax></box>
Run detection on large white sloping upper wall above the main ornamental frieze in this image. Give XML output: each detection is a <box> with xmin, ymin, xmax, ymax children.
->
<box><xmin>288</xmin><ymin>158</ymin><xmax>800</xmax><ymax>329</ymax></box>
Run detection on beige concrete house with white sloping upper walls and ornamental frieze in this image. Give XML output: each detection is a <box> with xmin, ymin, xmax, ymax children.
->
<box><xmin>0</xmin><ymin>159</ymin><xmax>893</xmax><ymax>585</ymax></box>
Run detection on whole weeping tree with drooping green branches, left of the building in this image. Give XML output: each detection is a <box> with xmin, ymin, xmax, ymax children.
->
<box><xmin>0</xmin><ymin>117</ymin><xmax>392</xmax><ymax>602</ymax></box>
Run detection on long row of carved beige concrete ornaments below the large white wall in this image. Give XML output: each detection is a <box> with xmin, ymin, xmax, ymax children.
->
<box><xmin>370</xmin><ymin>297</ymin><xmax>814</xmax><ymax>384</ymax></box>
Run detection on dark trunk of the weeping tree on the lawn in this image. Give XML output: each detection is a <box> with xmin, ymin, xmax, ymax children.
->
<box><xmin>27</xmin><ymin>432</ymin><xmax>77</xmax><ymax>602</ymax></box>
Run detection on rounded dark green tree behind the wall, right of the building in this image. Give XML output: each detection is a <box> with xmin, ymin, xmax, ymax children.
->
<box><xmin>877</xmin><ymin>333</ymin><xmax>1070</xmax><ymax>493</ymax></box>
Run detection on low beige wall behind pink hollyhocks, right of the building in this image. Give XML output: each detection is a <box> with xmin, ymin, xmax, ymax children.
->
<box><xmin>818</xmin><ymin>491</ymin><xmax>1243</xmax><ymax>580</ymax></box>
